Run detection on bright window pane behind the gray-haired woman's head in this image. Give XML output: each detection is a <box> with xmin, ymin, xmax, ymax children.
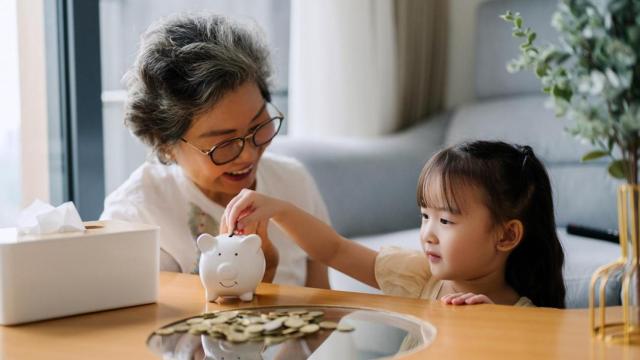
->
<box><xmin>100</xmin><ymin>0</ymin><xmax>290</xmax><ymax>194</ymax></box>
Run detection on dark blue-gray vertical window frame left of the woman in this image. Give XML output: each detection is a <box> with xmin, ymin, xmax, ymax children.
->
<box><xmin>45</xmin><ymin>0</ymin><xmax>105</xmax><ymax>220</ymax></box>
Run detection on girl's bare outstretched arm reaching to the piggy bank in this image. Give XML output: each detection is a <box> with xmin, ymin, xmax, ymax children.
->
<box><xmin>222</xmin><ymin>189</ymin><xmax>378</xmax><ymax>288</ymax></box>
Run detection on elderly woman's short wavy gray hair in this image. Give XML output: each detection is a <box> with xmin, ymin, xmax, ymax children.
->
<box><xmin>124</xmin><ymin>14</ymin><xmax>271</xmax><ymax>164</ymax></box>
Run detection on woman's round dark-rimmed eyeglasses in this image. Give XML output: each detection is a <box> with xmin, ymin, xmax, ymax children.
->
<box><xmin>180</xmin><ymin>102</ymin><xmax>284</xmax><ymax>165</ymax></box>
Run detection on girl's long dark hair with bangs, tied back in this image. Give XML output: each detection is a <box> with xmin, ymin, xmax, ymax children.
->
<box><xmin>418</xmin><ymin>141</ymin><xmax>565</xmax><ymax>308</ymax></box>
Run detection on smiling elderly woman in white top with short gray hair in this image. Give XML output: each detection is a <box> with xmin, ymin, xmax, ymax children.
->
<box><xmin>101</xmin><ymin>15</ymin><xmax>329</xmax><ymax>288</ymax></box>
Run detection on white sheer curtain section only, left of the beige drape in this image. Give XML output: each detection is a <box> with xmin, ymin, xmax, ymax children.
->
<box><xmin>288</xmin><ymin>0</ymin><xmax>399</xmax><ymax>137</ymax></box>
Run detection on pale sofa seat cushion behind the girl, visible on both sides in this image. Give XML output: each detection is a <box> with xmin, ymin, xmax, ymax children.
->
<box><xmin>329</xmin><ymin>228</ymin><xmax>621</xmax><ymax>308</ymax></box>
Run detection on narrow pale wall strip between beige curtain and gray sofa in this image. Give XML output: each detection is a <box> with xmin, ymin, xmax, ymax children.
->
<box><xmin>445</xmin><ymin>0</ymin><xmax>487</xmax><ymax>109</ymax></box>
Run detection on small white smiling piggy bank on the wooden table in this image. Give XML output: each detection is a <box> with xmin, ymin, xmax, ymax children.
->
<box><xmin>197</xmin><ymin>234</ymin><xmax>266</xmax><ymax>301</ymax></box>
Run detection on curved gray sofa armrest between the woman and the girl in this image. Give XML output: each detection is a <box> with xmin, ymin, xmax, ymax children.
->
<box><xmin>268</xmin><ymin>113</ymin><xmax>450</xmax><ymax>236</ymax></box>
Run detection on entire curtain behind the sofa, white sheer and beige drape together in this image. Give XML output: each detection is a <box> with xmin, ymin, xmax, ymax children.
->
<box><xmin>289</xmin><ymin>0</ymin><xmax>448</xmax><ymax>137</ymax></box>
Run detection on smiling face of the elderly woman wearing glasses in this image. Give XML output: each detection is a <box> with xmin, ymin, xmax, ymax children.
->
<box><xmin>173</xmin><ymin>82</ymin><xmax>269</xmax><ymax>206</ymax></box>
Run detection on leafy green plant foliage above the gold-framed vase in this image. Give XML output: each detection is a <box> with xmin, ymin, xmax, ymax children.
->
<box><xmin>501</xmin><ymin>0</ymin><xmax>640</xmax><ymax>184</ymax></box>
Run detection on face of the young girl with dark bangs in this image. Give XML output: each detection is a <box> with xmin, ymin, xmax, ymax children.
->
<box><xmin>420</xmin><ymin>186</ymin><xmax>505</xmax><ymax>281</ymax></box>
